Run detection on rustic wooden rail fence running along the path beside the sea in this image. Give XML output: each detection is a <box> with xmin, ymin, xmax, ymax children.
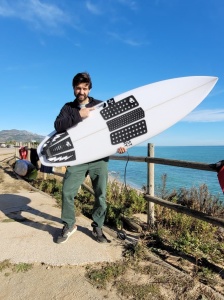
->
<box><xmin>13</xmin><ymin>143</ymin><xmax>224</xmax><ymax>227</ymax></box>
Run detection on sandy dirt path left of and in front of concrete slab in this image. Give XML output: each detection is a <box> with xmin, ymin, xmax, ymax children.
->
<box><xmin>0</xmin><ymin>149</ymin><xmax>120</xmax><ymax>300</ymax></box>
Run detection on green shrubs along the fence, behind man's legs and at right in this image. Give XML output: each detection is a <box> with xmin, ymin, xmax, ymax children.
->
<box><xmin>30</xmin><ymin>176</ymin><xmax>224</xmax><ymax>261</ymax></box>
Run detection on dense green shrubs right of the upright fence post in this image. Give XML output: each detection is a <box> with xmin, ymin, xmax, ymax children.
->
<box><xmin>147</xmin><ymin>177</ymin><xmax>224</xmax><ymax>264</ymax></box>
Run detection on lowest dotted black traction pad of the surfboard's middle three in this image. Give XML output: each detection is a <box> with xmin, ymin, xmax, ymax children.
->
<box><xmin>110</xmin><ymin>120</ymin><xmax>147</xmax><ymax>145</ymax></box>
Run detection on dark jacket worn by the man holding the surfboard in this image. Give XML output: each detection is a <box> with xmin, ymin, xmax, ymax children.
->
<box><xmin>54</xmin><ymin>97</ymin><xmax>102</xmax><ymax>133</ymax></box>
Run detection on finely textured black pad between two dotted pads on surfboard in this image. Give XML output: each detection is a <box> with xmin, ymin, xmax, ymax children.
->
<box><xmin>107</xmin><ymin>107</ymin><xmax>145</xmax><ymax>131</ymax></box>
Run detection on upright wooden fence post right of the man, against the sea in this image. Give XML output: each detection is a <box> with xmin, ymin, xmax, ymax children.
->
<box><xmin>147</xmin><ymin>143</ymin><xmax>155</xmax><ymax>226</ymax></box>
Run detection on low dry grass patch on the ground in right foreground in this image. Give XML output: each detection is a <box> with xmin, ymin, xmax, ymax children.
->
<box><xmin>86</xmin><ymin>242</ymin><xmax>220</xmax><ymax>300</ymax></box>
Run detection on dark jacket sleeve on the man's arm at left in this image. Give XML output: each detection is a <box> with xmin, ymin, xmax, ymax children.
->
<box><xmin>54</xmin><ymin>104</ymin><xmax>82</xmax><ymax>133</ymax></box>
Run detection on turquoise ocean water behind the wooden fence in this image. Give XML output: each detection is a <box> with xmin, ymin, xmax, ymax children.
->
<box><xmin>109</xmin><ymin>145</ymin><xmax>224</xmax><ymax>200</ymax></box>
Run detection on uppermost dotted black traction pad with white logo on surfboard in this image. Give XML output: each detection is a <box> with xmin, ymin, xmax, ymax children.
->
<box><xmin>100</xmin><ymin>96</ymin><xmax>139</xmax><ymax>120</ymax></box>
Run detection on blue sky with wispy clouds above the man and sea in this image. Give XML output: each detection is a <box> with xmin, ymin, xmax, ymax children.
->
<box><xmin>0</xmin><ymin>0</ymin><xmax>224</xmax><ymax>145</ymax></box>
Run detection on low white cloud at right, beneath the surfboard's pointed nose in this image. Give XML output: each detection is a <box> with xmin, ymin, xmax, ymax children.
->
<box><xmin>182</xmin><ymin>109</ymin><xmax>224</xmax><ymax>122</ymax></box>
